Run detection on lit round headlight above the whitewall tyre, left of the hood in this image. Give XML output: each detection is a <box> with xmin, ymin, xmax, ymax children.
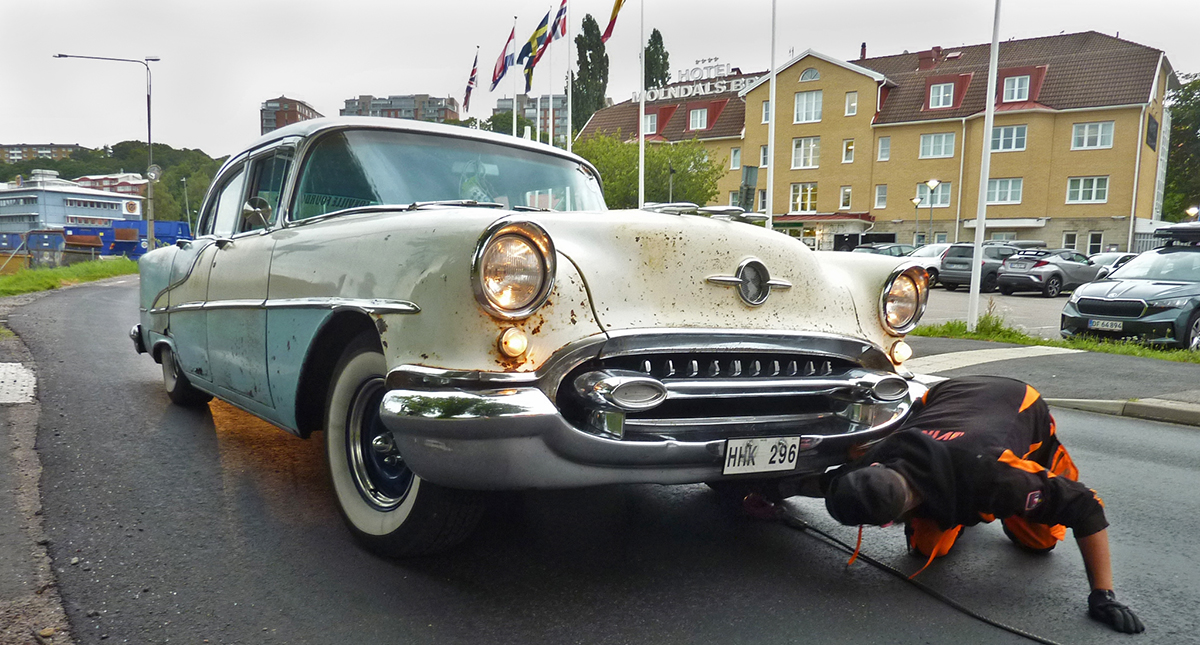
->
<box><xmin>473</xmin><ymin>222</ymin><xmax>554</xmax><ymax>320</ymax></box>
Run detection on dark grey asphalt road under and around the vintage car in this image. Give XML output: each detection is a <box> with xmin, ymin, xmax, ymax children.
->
<box><xmin>10</xmin><ymin>278</ymin><xmax>1200</xmax><ymax>645</ymax></box>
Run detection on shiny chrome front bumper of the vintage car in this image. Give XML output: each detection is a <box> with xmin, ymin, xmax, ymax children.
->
<box><xmin>380</xmin><ymin>330</ymin><xmax>925</xmax><ymax>489</ymax></box>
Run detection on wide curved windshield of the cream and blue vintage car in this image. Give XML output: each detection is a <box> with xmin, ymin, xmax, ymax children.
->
<box><xmin>292</xmin><ymin>129</ymin><xmax>605</xmax><ymax>219</ymax></box>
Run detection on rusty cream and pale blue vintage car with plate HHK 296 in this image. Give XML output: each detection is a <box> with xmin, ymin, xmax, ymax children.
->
<box><xmin>131</xmin><ymin>117</ymin><xmax>928</xmax><ymax>555</ymax></box>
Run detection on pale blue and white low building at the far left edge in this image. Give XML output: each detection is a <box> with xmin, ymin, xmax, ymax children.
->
<box><xmin>0</xmin><ymin>170</ymin><xmax>145</xmax><ymax>233</ymax></box>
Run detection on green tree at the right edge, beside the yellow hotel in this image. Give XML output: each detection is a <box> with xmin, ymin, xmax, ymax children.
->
<box><xmin>1163</xmin><ymin>73</ymin><xmax>1200</xmax><ymax>222</ymax></box>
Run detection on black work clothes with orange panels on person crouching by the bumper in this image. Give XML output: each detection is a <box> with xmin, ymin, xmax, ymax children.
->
<box><xmin>824</xmin><ymin>376</ymin><xmax>1108</xmax><ymax>538</ymax></box>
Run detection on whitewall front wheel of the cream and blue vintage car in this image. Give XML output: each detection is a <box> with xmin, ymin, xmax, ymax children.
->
<box><xmin>324</xmin><ymin>332</ymin><xmax>484</xmax><ymax>557</ymax></box>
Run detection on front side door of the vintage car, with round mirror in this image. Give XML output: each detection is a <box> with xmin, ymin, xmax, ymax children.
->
<box><xmin>206</xmin><ymin>146</ymin><xmax>292</xmax><ymax>409</ymax></box>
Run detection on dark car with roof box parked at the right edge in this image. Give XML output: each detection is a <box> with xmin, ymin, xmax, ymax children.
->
<box><xmin>1060</xmin><ymin>224</ymin><xmax>1200</xmax><ymax>350</ymax></box>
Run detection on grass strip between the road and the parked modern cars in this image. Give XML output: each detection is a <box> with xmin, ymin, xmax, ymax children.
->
<box><xmin>908</xmin><ymin>306</ymin><xmax>1200</xmax><ymax>363</ymax></box>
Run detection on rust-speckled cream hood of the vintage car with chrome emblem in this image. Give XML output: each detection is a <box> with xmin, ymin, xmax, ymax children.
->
<box><xmin>536</xmin><ymin>211</ymin><xmax>896</xmax><ymax>337</ymax></box>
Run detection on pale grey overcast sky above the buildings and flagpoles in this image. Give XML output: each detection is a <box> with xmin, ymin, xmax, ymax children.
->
<box><xmin>0</xmin><ymin>0</ymin><xmax>1200</xmax><ymax>157</ymax></box>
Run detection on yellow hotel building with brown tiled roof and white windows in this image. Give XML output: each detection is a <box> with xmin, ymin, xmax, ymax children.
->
<box><xmin>742</xmin><ymin>31</ymin><xmax>1178</xmax><ymax>253</ymax></box>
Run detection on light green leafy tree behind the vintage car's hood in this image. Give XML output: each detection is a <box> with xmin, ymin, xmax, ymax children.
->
<box><xmin>574</xmin><ymin>132</ymin><xmax>725</xmax><ymax>209</ymax></box>
